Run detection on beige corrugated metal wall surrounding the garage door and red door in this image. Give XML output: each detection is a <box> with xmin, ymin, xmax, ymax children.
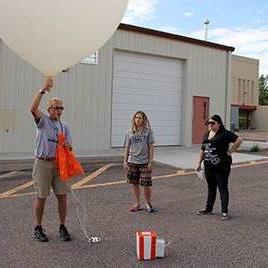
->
<box><xmin>0</xmin><ymin>30</ymin><xmax>227</xmax><ymax>152</ymax></box>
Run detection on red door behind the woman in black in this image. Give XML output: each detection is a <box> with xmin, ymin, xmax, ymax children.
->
<box><xmin>192</xmin><ymin>96</ymin><xmax>209</xmax><ymax>144</ymax></box>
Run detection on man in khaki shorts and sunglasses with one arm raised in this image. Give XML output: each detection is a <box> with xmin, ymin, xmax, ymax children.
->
<box><xmin>31</xmin><ymin>78</ymin><xmax>72</xmax><ymax>242</ymax></box>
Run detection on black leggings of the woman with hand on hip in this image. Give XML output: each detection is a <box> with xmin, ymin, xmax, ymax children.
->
<box><xmin>205</xmin><ymin>166</ymin><xmax>231</xmax><ymax>213</ymax></box>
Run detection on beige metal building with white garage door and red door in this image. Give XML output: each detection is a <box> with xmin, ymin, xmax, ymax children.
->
<box><xmin>0</xmin><ymin>24</ymin><xmax>234</xmax><ymax>153</ymax></box>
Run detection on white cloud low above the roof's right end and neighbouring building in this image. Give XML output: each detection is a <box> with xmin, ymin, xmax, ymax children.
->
<box><xmin>188</xmin><ymin>26</ymin><xmax>268</xmax><ymax>75</ymax></box>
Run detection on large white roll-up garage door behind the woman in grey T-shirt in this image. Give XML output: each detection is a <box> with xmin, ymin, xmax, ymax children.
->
<box><xmin>111</xmin><ymin>51</ymin><xmax>182</xmax><ymax>147</ymax></box>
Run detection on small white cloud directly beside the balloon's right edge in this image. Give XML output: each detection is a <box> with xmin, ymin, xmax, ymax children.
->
<box><xmin>122</xmin><ymin>0</ymin><xmax>158</xmax><ymax>25</ymax></box>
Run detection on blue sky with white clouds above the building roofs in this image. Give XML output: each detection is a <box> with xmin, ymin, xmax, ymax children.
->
<box><xmin>122</xmin><ymin>0</ymin><xmax>268</xmax><ymax>75</ymax></box>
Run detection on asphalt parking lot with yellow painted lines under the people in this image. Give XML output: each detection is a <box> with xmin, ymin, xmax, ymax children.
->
<box><xmin>0</xmin><ymin>161</ymin><xmax>268</xmax><ymax>267</ymax></box>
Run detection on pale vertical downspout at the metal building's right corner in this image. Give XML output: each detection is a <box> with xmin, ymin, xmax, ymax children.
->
<box><xmin>224</xmin><ymin>51</ymin><xmax>232</xmax><ymax>129</ymax></box>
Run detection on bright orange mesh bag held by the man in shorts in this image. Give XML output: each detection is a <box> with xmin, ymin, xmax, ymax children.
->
<box><xmin>56</xmin><ymin>132</ymin><xmax>84</xmax><ymax>181</ymax></box>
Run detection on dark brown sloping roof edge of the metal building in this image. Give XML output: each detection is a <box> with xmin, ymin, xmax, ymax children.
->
<box><xmin>118</xmin><ymin>23</ymin><xmax>235</xmax><ymax>52</ymax></box>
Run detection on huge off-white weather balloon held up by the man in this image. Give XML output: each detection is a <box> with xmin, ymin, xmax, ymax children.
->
<box><xmin>0</xmin><ymin>0</ymin><xmax>128</xmax><ymax>75</ymax></box>
